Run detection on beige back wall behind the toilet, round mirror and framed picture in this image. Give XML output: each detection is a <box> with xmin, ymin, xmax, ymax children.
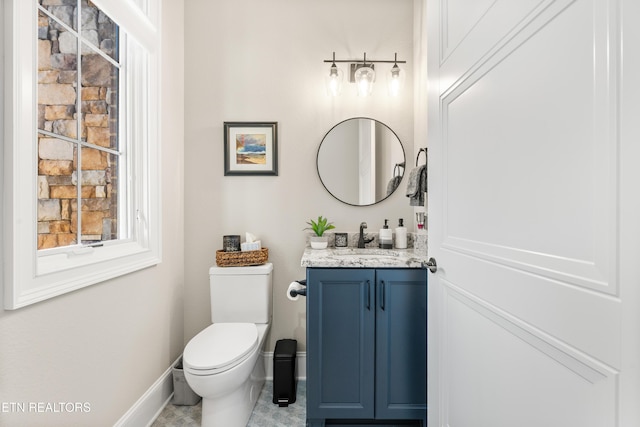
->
<box><xmin>185</xmin><ymin>0</ymin><xmax>415</xmax><ymax>350</ymax></box>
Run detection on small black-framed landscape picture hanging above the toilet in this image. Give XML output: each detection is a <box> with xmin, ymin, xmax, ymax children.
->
<box><xmin>224</xmin><ymin>122</ymin><xmax>278</xmax><ymax>176</ymax></box>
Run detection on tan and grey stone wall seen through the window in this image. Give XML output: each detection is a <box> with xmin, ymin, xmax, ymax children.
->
<box><xmin>38</xmin><ymin>0</ymin><xmax>118</xmax><ymax>249</ymax></box>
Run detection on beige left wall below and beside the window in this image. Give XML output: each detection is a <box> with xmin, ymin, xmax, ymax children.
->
<box><xmin>0</xmin><ymin>0</ymin><xmax>184</xmax><ymax>427</ymax></box>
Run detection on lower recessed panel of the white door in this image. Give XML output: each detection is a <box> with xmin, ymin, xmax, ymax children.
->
<box><xmin>442</xmin><ymin>284</ymin><xmax>617</xmax><ymax>427</ymax></box>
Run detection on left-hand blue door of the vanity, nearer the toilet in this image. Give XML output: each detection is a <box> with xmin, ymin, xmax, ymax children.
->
<box><xmin>307</xmin><ymin>268</ymin><xmax>375</xmax><ymax>420</ymax></box>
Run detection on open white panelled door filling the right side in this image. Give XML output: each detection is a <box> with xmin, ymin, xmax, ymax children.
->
<box><xmin>426</xmin><ymin>0</ymin><xmax>640</xmax><ymax>427</ymax></box>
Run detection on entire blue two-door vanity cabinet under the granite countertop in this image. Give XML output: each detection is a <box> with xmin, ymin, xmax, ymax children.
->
<box><xmin>307</xmin><ymin>268</ymin><xmax>427</xmax><ymax>427</ymax></box>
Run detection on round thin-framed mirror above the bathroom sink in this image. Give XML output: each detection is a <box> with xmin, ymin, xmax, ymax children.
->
<box><xmin>317</xmin><ymin>117</ymin><xmax>406</xmax><ymax>206</ymax></box>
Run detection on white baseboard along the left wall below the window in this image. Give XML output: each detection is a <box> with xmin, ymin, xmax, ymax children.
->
<box><xmin>114</xmin><ymin>355</ymin><xmax>182</xmax><ymax>427</ymax></box>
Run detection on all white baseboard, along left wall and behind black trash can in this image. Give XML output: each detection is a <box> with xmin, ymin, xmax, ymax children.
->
<box><xmin>114</xmin><ymin>351</ymin><xmax>307</xmax><ymax>427</ymax></box>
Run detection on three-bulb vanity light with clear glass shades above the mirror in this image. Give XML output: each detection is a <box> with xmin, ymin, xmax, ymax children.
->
<box><xmin>324</xmin><ymin>52</ymin><xmax>407</xmax><ymax>96</ymax></box>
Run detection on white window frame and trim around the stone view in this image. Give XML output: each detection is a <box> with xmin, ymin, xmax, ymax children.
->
<box><xmin>0</xmin><ymin>0</ymin><xmax>161</xmax><ymax>309</ymax></box>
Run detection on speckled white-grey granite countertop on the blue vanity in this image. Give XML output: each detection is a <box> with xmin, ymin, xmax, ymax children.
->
<box><xmin>300</xmin><ymin>248</ymin><xmax>427</xmax><ymax>268</ymax></box>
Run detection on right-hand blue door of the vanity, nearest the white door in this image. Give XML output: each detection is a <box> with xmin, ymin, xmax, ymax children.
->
<box><xmin>376</xmin><ymin>269</ymin><xmax>427</xmax><ymax>420</ymax></box>
